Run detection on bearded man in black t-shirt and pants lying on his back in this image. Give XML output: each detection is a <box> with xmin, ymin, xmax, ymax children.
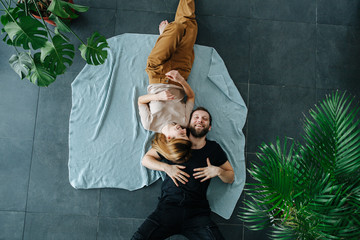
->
<box><xmin>132</xmin><ymin>108</ymin><xmax>234</xmax><ymax>240</ymax></box>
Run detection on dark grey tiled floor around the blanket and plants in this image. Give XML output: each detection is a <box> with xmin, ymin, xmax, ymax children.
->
<box><xmin>0</xmin><ymin>0</ymin><xmax>360</xmax><ymax>240</ymax></box>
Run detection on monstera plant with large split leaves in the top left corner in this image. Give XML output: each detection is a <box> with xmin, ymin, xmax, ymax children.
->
<box><xmin>0</xmin><ymin>0</ymin><xmax>108</xmax><ymax>86</ymax></box>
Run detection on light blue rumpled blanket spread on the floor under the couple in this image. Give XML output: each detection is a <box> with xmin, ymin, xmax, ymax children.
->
<box><xmin>69</xmin><ymin>34</ymin><xmax>247</xmax><ymax>219</ymax></box>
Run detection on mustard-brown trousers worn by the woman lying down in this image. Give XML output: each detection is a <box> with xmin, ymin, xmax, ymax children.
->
<box><xmin>146</xmin><ymin>0</ymin><xmax>197</xmax><ymax>85</ymax></box>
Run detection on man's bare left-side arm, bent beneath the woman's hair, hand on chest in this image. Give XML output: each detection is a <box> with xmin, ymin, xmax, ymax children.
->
<box><xmin>141</xmin><ymin>148</ymin><xmax>190</xmax><ymax>187</ymax></box>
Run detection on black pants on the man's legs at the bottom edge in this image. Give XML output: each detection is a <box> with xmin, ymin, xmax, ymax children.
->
<box><xmin>132</xmin><ymin>203</ymin><xmax>224</xmax><ymax>240</ymax></box>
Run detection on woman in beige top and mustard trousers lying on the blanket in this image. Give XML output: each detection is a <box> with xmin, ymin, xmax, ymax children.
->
<box><xmin>138</xmin><ymin>0</ymin><xmax>197</xmax><ymax>160</ymax></box>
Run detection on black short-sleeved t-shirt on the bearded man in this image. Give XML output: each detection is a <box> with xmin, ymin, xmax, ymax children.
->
<box><xmin>160</xmin><ymin>140</ymin><xmax>227</xmax><ymax>208</ymax></box>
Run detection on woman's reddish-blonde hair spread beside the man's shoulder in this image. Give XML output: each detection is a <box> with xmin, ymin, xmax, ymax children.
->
<box><xmin>152</xmin><ymin>133</ymin><xmax>191</xmax><ymax>163</ymax></box>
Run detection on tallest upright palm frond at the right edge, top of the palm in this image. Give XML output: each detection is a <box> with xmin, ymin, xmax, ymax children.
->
<box><xmin>304</xmin><ymin>92</ymin><xmax>360</xmax><ymax>179</ymax></box>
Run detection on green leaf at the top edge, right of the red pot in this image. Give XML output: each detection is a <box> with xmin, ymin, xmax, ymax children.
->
<box><xmin>48</xmin><ymin>0</ymin><xmax>89</xmax><ymax>19</ymax></box>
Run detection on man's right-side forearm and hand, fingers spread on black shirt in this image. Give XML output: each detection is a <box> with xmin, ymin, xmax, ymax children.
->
<box><xmin>194</xmin><ymin>158</ymin><xmax>234</xmax><ymax>183</ymax></box>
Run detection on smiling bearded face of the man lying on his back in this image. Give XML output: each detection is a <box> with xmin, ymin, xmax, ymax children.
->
<box><xmin>189</xmin><ymin>110</ymin><xmax>211</xmax><ymax>138</ymax></box>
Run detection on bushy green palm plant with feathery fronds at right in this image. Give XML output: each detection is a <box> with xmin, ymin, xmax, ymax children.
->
<box><xmin>240</xmin><ymin>92</ymin><xmax>360</xmax><ymax>240</ymax></box>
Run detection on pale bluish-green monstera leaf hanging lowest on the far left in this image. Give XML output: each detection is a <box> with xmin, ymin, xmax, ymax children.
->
<box><xmin>9</xmin><ymin>52</ymin><xmax>33</xmax><ymax>79</ymax></box>
